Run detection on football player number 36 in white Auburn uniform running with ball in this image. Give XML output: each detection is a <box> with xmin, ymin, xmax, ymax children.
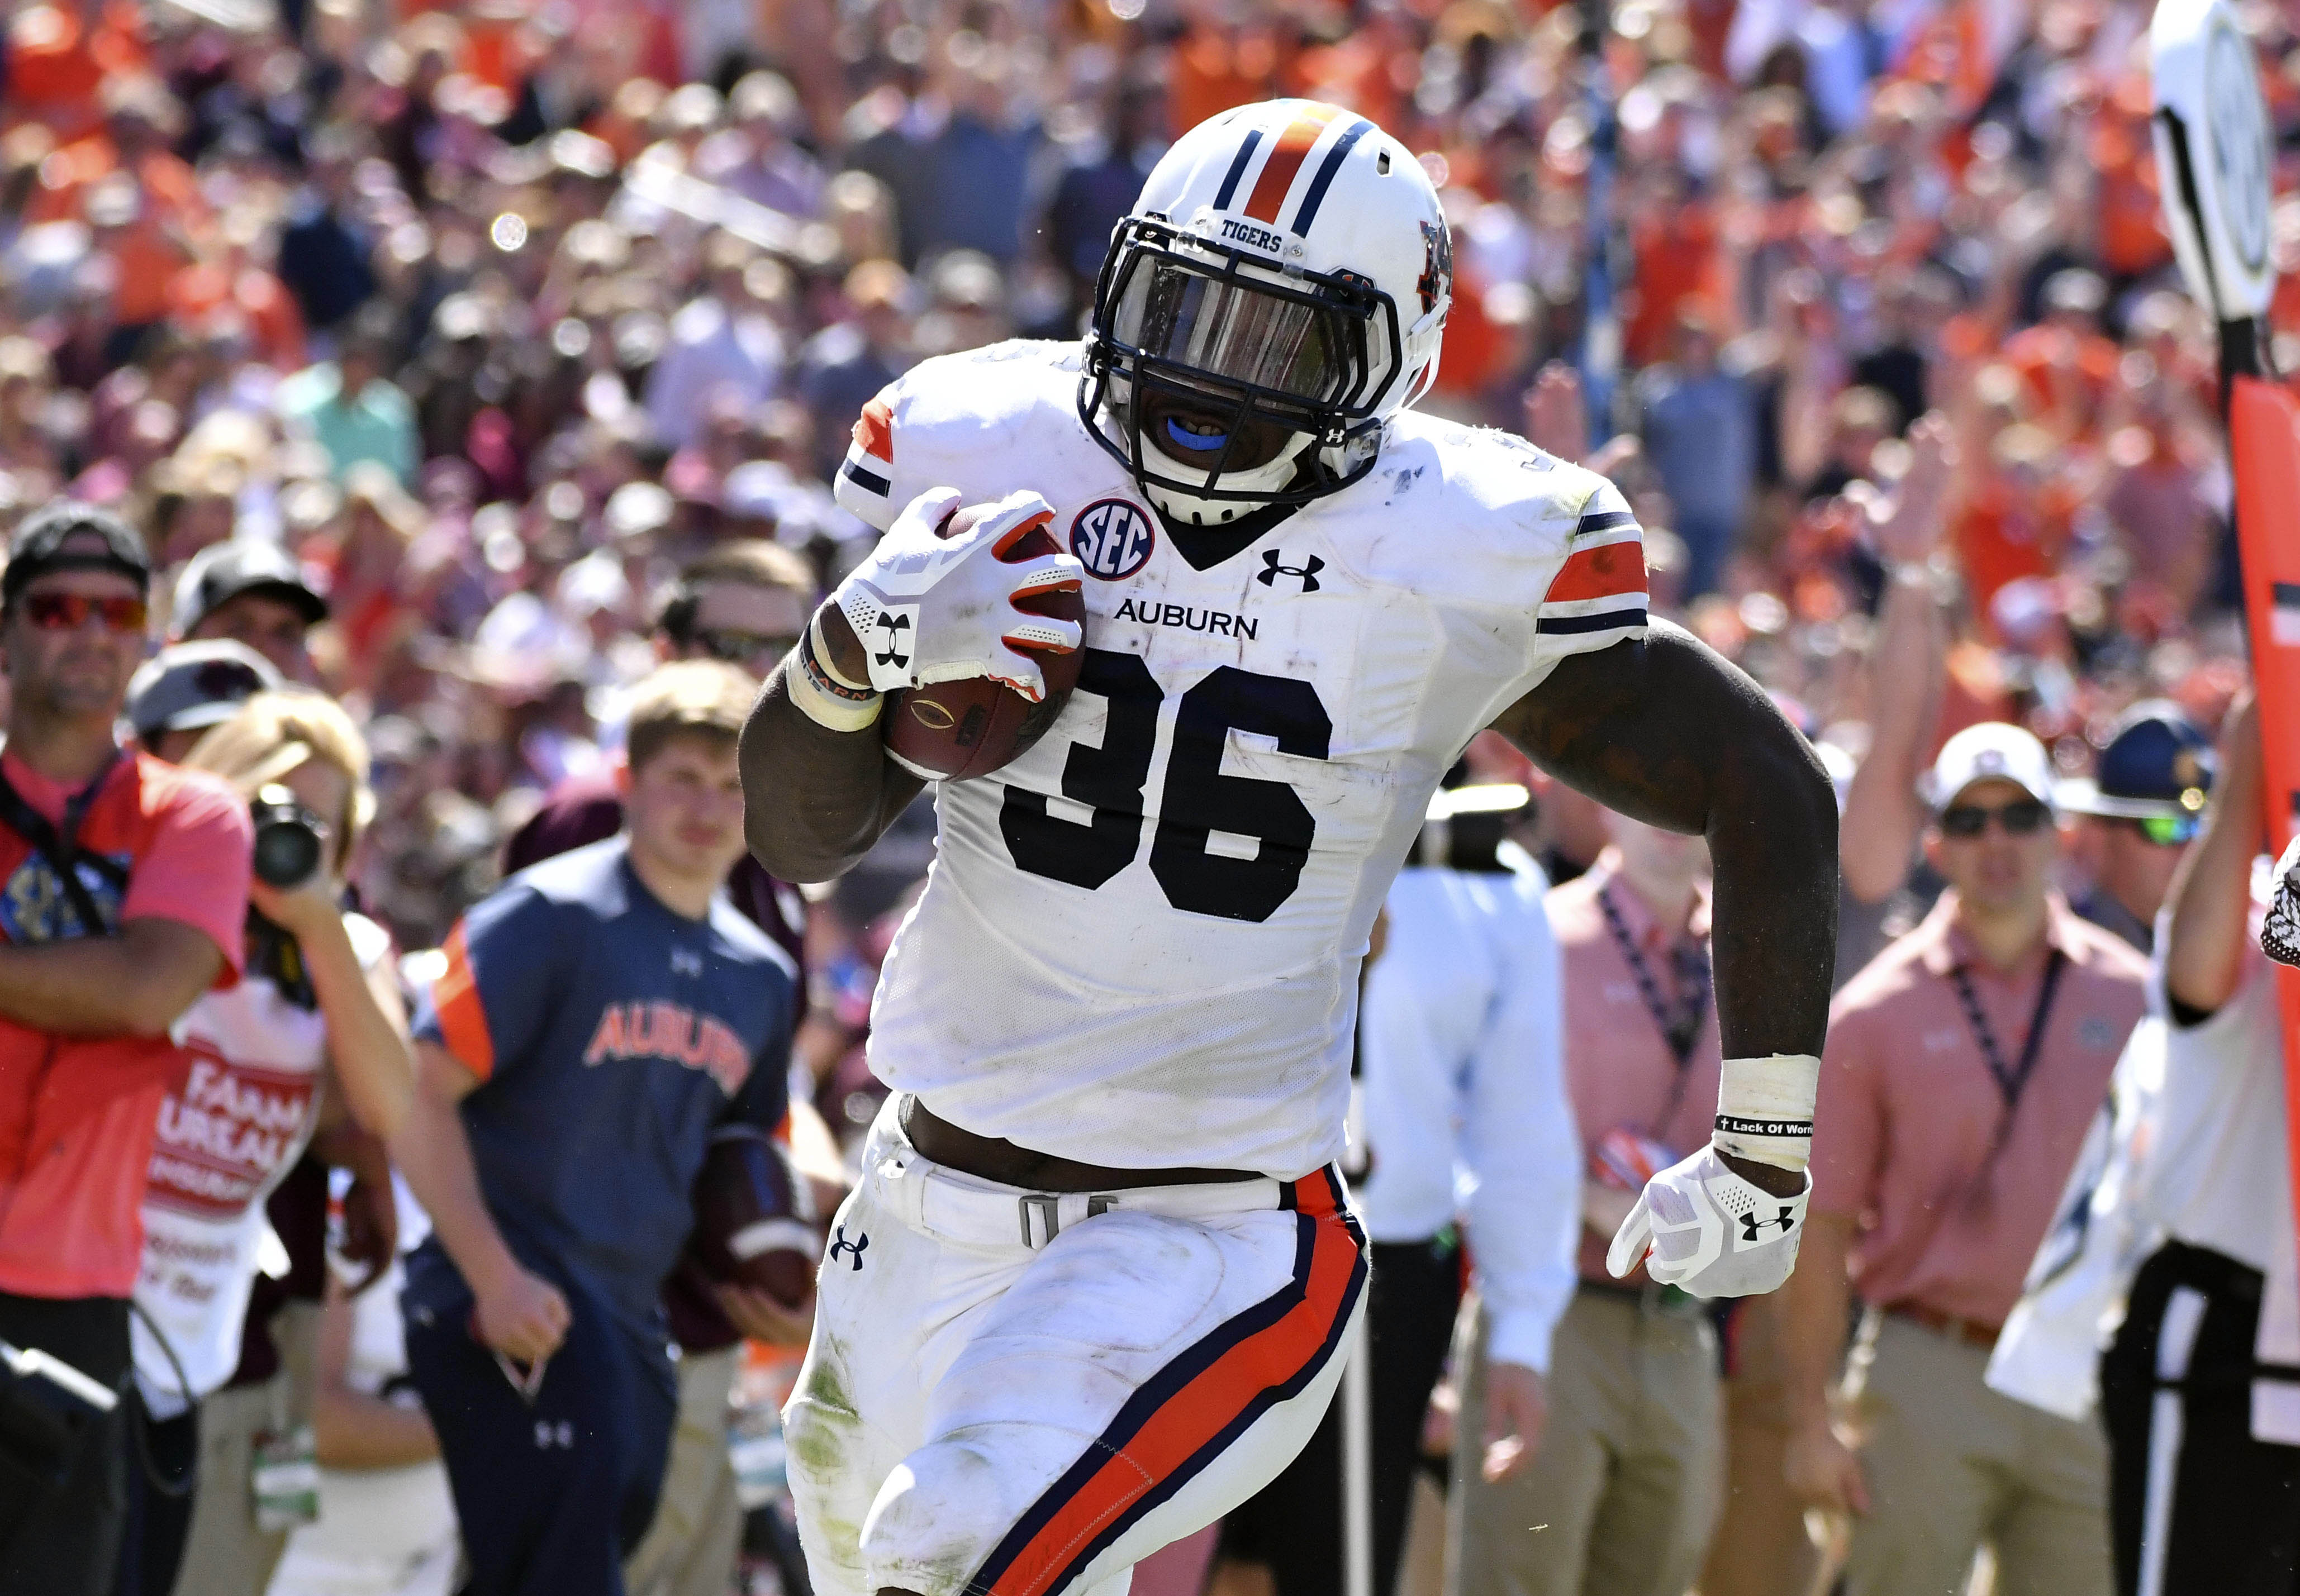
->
<box><xmin>743</xmin><ymin>101</ymin><xmax>1836</xmax><ymax>1596</ymax></box>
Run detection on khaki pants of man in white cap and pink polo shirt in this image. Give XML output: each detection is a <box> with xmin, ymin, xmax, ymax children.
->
<box><xmin>1845</xmin><ymin>1313</ymin><xmax>2107</xmax><ymax>1596</ymax></box>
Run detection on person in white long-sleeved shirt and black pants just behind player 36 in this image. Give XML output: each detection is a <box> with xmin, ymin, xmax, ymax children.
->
<box><xmin>1222</xmin><ymin>784</ymin><xmax>1580</xmax><ymax>1596</ymax></box>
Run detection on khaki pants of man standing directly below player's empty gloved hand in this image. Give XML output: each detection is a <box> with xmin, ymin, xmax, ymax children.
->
<box><xmin>1447</xmin><ymin>1288</ymin><xmax>1721</xmax><ymax>1596</ymax></box>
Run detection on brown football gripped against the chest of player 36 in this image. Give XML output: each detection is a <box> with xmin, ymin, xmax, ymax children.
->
<box><xmin>881</xmin><ymin>504</ymin><xmax>1086</xmax><ymax>782</ymax></box>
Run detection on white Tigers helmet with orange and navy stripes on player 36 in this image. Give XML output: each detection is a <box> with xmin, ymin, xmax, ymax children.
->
<box><xmin>1078</xmin><ymin>99</ymin><xmax>1453</xmax><ymax>525</ymax></box>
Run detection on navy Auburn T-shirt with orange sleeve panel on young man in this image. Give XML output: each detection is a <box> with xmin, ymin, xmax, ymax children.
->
<box><xmin>416</xmin><ymin>837</ymin><xmax>796</xmax><ymax>1327</ymax></box>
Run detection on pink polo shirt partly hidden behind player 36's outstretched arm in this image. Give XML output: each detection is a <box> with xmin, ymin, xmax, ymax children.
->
<box><xmin>1546</xmin><ymin>864</ymin><xmax>1723</xmax><ymax>1281</ymax></box>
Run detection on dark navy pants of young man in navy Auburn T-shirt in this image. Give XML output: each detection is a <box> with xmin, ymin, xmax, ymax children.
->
<box><xmin>402</xmin><ymin>1242</ymin><xmax>678</xmax><ymax>1596</ymax></box>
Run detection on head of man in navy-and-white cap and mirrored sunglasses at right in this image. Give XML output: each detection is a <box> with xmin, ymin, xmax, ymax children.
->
<box><xmin>2059</xmin><ymin>699</ymin><xmax>2217</xmax><ymax>952</ymax></box>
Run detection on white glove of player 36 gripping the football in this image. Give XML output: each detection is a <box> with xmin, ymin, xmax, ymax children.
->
<box><xmin>833</xmin><ymin>488</ymin><xmax>1086</xmax><ymax>704</ymax></box>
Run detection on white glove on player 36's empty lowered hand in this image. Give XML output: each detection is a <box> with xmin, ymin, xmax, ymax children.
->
<box><xmin>1605</xmin><ymin>1147</ymin><xmax>1812</xmax><ymax>1297</ymax></box>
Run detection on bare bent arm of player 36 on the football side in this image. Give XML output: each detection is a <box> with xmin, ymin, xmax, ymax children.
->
<box><xmin>743</xmin><ymin>609</ymin><xmax>925</xmax><ymax>881</ymax></box>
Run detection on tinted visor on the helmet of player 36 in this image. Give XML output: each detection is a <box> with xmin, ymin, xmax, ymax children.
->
<box><xmin>1111</xmin><ymin>255</ymin><xmax>1373</xmax><ymax>418</ymax></box>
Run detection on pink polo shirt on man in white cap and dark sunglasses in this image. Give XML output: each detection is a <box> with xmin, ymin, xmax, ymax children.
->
<box><xmin>1812</xmin><ymin>892</ymin><xmax>2148</xmax><ymax>1327</ymax></box>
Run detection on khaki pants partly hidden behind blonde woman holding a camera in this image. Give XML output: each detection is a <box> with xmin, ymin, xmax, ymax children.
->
<box><xmin>171</xmin><ymin>1302</ymin><xmax>320</xmax><ymax>1596</ymax></box>
